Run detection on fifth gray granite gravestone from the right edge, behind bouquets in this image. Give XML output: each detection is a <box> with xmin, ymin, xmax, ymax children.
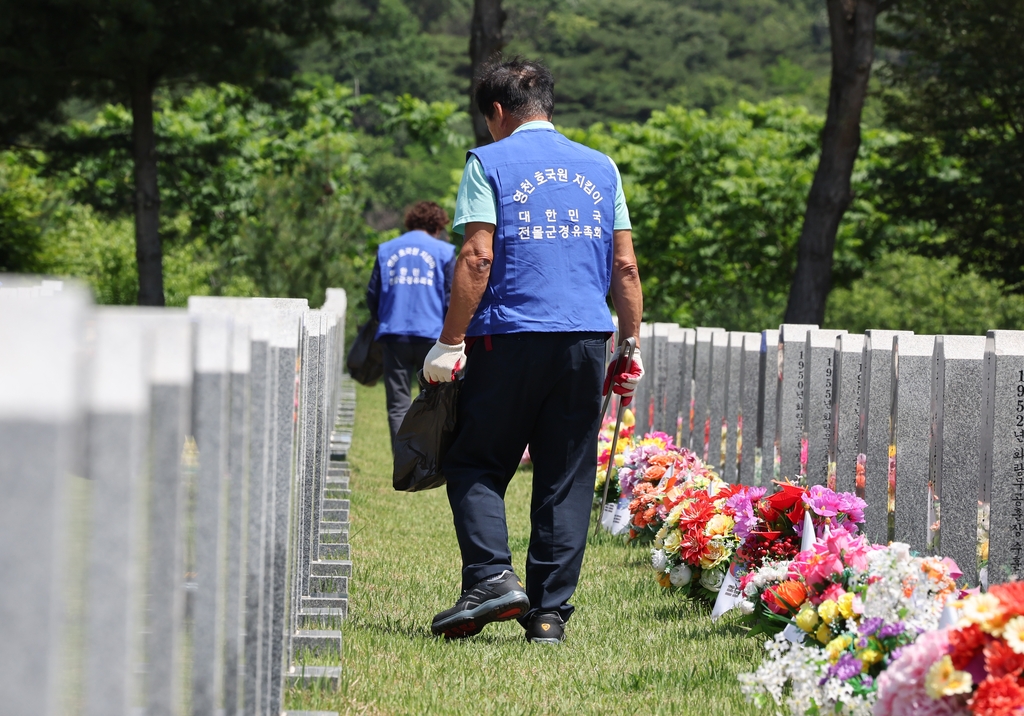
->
<box><xmin>826</xmin><ymin>333</ymin><xmax>864</xmax><ymax>497</ymax></box>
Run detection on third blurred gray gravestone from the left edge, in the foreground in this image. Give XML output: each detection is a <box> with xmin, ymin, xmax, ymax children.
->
<box><xmin>137</xmin><ymin>308</ymin><xmax>195</xmax><ymax>716</ymax></box>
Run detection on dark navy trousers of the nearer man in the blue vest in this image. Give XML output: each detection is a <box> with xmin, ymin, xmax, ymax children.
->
<box><xmin>442</xmin><ymin>333</ymin><xmax>608</xmax><ymax>620</ymax></box>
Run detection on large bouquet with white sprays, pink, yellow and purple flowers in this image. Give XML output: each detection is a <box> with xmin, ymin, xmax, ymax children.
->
<box><xmin>739</xmin><ymin>540</ymin><xmax>961</xmax><ymax>716</ymax></box>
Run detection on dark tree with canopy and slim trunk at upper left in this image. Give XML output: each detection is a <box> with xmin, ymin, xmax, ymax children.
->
<box><xmin>0</xmin><ymin>0</ymin><xmax>333</xmax><ymax>305</ymax></box>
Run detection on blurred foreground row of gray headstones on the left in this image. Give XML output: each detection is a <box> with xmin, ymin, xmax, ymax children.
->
<box><xmin>0</xmin><ymin>276</ymin><xmax>354</xmax><ymax>716</ymax></box>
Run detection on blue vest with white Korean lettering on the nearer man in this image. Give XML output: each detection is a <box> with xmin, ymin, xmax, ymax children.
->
<box><xmin>466</xmin><ymin>129</ymin><xmax>616</xmax><ymax>336</ymax></box>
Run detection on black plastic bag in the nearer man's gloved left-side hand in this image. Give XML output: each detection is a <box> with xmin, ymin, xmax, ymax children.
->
<box><xmin>391</xmin><ymin>371</ymin><xmax>462</xmax><ymax>493</ymax></box>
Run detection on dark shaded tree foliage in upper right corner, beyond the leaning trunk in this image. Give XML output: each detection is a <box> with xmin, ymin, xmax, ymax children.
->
<box><xmin>879</xmin><ymin>0</ymin><xmax>1024</xmax><ymax>292</ymax></box>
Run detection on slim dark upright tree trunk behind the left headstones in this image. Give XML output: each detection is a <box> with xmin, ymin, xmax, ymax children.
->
<box><xmin>131</xmin><ymin>80</ymin><xmax>164</xmax><ymax>306</ymax></box>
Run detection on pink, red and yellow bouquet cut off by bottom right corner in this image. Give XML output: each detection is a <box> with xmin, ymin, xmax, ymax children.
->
<box><xmin>874</xmin><ymin>582</ymin><xmax>1024</xmax><ymax>716</ymax></box>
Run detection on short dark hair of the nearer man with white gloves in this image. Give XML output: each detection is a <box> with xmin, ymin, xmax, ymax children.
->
<box><xmin>475</xmin><ymin>56</ymin><xmax>555</xmax><ymax>120</ymax></box>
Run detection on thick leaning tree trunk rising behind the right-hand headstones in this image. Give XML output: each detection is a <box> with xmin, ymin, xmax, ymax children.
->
<box><xmin>785</xmin><ymin>0</ymin><xmax>878</xmax><ymax>325</ymax></box>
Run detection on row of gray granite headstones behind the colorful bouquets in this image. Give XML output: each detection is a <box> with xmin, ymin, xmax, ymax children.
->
<box><xmin>622</xmin><ymin>324</ymin><xmax>1024</xmax><ymax>584</ymax></box>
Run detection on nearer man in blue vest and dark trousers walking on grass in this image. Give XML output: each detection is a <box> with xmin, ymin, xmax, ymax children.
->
<box><xmin>423</xmin><ymin>58</ymin><xmax>643</xmax><ymax>643</ymax></box>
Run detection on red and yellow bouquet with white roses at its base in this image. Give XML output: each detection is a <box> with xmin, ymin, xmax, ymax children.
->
<box><xmin>651</xmin><ymin>480</ymin><xmax>748</xmax><ymax>602</ymax></box>
